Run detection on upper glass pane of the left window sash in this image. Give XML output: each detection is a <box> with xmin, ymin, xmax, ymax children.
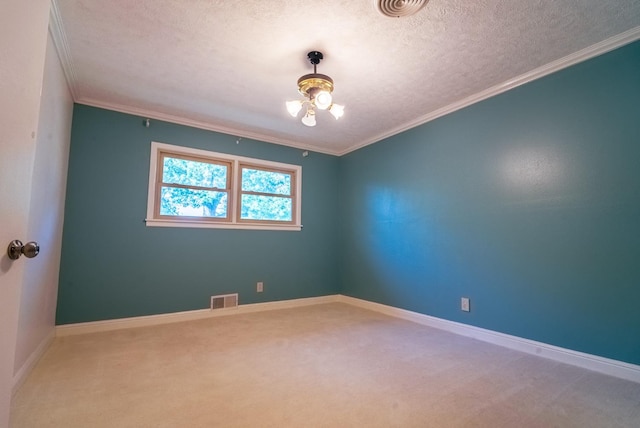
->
<box><xmin>162</xmin><ymin>157</ymin><xmax>227</xmax><ymax>189</ymax></box>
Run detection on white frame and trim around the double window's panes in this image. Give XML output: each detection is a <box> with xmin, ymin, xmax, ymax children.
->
<box><xmin>145</xmin><ymin>141</ymin><xmax>302</xmax><ymax>231</ymax></box>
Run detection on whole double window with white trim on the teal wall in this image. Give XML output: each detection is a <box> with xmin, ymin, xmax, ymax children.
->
<box><xmin>146</xmin><ymin>142</ymin><xmax>302</xmax><ymax>230</ymax></box>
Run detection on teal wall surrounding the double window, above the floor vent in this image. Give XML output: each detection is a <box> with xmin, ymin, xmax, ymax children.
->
<box><xmin>56</xmin><ymin>105</ymin><xmax>339</xmax><ymax>324</ymax></box>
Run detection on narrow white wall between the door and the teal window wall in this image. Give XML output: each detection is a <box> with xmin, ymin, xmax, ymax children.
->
<box><xmin>14</xmin><ymin>28</ymin><xmax>73</xmax><ymax>384</ymax></box>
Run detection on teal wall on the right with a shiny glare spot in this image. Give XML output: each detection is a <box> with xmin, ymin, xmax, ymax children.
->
<box><xmin>340</xmin><ymin>42</ymin><xmax>640</xmax><ymax>364</ymax></box>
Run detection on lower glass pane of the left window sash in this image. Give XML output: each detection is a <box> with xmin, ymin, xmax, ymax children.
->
<box><xmin>160</xmin><ymin>186</ymin><xmax>227</xmax><ymax>218</ymax></box>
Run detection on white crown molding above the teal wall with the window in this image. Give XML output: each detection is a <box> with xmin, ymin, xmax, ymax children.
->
<box><xmin>76</xmin><ymin>97</ymin><xmax>338</xmax><ymax>156</ymax></box>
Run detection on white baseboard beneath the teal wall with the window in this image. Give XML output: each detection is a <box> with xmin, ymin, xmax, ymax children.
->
<box><xmin>55</xmin><ymin>295</ymin><xmax>338</xmax><ymax>337</ymax></box>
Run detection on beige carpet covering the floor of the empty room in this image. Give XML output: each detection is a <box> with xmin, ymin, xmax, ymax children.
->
<box><xmin>11</xmin><ymin>303</ymin><xmax>640</xmax><ymax>428</ymax></box>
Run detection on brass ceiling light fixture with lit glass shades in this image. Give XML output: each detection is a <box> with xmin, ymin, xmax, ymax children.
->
<box><xmin>286</xmin><ymin>51</ymin><xmax>344</xmax><ymax>126</ymax></box>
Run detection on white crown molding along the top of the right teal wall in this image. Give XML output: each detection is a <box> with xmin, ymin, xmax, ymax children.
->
<box><xmin>337</xmin><ymin>26</ymin><xmax>640</xmax><ymax>156</ymax></box>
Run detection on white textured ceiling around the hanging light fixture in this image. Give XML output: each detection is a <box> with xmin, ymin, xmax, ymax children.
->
<box><xmin>52</xmin><ymin>0</ymin><xmax>640</xmax><ymax>154</ymax></box>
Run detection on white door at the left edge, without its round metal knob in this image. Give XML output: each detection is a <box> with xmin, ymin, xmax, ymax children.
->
<box><xmin>0</xmin><ymin>0</ymin><xmax>50</xmax><ymax>427</ymax></box>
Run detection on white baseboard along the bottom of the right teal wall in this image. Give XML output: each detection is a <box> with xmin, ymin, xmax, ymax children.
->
<box><xmin>337</xmin><ymin>295</ymin><xmax>640</xmax><ymax>383</ymax></box>
